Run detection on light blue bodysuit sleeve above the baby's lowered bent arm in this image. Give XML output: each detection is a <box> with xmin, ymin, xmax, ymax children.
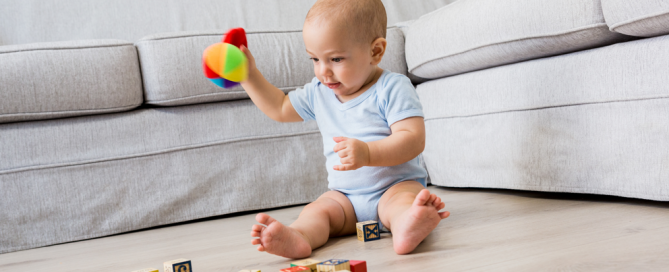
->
<box><xmin>379</xmin><ymin>74</ymin><xmax>424</xmax><ymax>126</ymax></box>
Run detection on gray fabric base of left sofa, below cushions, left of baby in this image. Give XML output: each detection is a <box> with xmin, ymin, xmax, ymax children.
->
<box><xmin>0</xmin><ymin>100</ymin><xmax>327</xmax><ymax>253</ymax></box>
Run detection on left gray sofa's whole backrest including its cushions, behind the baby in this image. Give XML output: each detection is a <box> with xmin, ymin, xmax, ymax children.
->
<box><xmin>0</xmin><ymin>0</ymin><xmax>454</xmax><ymax>123</ymax></box>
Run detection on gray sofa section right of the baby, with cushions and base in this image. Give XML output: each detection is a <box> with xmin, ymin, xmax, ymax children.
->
<box><xmin>405</xmin><ymin>0</ymin><xmax>669</xmax><ymax>201</ymax></box>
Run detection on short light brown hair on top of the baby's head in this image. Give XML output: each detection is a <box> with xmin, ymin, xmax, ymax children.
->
<box><xmin>304</xmin><ymin>0</ymin><xmax>388</xmax><ymax>44</ymax></box>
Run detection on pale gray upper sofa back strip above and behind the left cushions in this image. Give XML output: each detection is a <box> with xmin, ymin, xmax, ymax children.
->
<box><xmin>0</xmin><ymin>0</ymin><xmax>454</xmax><ymax>45</ymax></box>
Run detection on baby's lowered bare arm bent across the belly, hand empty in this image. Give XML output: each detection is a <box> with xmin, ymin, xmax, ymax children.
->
<box><xmin>333</xmin><ymin>117</ymin><xmax>425</xmax><ymax>171</ymax></box>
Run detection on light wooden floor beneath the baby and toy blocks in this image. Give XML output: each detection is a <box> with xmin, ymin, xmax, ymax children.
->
<box><xmin>0</xmin><ymin>187</ymin><xmax>669</xmax><ymax>272</ymax></box>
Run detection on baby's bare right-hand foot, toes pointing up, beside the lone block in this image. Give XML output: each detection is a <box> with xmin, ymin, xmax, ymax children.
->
<box><xmin>392</xmin><ymin>189</ymin><xmax>450</xmax><ymax>254</ymax></box>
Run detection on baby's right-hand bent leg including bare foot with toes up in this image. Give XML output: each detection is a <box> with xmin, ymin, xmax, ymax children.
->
<box><xmin>379</xmin><ymin>181</ymin><xmax>450</xmax><ymax>254</ymax></box>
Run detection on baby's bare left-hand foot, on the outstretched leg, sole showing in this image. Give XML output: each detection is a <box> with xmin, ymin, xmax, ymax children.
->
<box><xmin>251</xmin><ymin>213</ymin><xmax>311</xmax><ymax>259</ymax></box>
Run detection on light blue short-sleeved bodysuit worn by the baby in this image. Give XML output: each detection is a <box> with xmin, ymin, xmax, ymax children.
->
<box><xmin>288</xmin><ymin>70</ymin><xmax>427</xmax><ymax>229</ymax></box>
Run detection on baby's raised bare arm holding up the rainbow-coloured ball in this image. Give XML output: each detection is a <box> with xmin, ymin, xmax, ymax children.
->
<box><xmin>240</xmin><ymin>46</ymin><xmax>303</xmax><ymax>122</ymax></box>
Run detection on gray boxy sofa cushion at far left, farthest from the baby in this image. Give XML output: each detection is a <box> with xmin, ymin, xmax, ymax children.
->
<box><xmin>0</xmin><ymin>40</ymin><xmax>142</xmax><ymax>123</ymax></box>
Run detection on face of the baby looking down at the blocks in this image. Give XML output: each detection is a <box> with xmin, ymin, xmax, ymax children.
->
<box><xmin>302</xmin><ymin>23</ymin><xmax>376</xmax><ymax>98</ymax></box>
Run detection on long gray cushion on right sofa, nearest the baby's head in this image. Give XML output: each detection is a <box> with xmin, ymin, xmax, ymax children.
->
<box><xmin>406</xmin><ymin>0</ymin><xmax>627</xmax><ymax>78</ymax></box>
